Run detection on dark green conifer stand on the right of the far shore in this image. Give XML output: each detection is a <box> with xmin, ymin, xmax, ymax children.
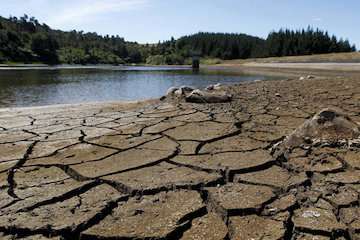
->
<box><xmin>157</xmin><ymin>27</ymin><xmax>356</xmax><ymax>60</ymax></box>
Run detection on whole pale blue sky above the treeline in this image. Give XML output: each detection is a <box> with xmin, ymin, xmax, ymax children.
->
<box><xmin>0</xmin><ymin>0</ymin><xmax>360</xmax><ymax>48</ymax></box>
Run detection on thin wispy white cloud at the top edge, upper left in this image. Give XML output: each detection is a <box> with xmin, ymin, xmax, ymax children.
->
<box><xmin>48</xmin><ymin>0</ymin><xmax>148</xmax><ymax>28</ymax></box>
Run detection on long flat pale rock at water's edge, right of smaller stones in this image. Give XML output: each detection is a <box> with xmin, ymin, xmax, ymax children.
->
<box><xmin>185</xmin><ymin>89</ymin><xmax>232</xmax><ymax>103</ymax></box>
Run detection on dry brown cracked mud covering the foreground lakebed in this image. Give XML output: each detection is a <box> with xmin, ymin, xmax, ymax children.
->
<box><xmin>0</xmin><ymin>68</ymin><xmax>360</xmax><ymax>240</ymax></box>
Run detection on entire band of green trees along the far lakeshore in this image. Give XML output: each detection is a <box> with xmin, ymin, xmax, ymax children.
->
<box><xmin>0</xmin><ymin>15</ymin><xmax>356</xmax><ymax>65</ymax></box>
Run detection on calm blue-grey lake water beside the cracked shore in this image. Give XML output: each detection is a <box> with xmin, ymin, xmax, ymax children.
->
<box><xmin>0</xmin><ymin>66</ymin><xmax>265</xmax><ymax>108</ymax></box>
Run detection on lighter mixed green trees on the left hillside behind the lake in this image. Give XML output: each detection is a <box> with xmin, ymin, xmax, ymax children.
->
<box><xmin>0</xmin><ymin>15</ymin><xmax>145</xmax><ymax>64</ymax></box>
